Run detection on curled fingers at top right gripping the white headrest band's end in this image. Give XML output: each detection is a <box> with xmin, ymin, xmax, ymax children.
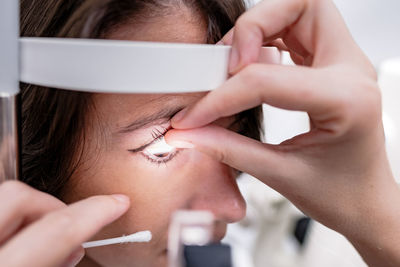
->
<box><xmin>222</xmin><ymin>0</ymin><xmax>368</xmax><ymax>74</ymax></box>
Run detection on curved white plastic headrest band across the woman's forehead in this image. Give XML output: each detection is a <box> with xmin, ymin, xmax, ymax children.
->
<box><xmin>20</xmin><ymin>38</ymin><xmax>279</xmax><ymax>93</ymax></box>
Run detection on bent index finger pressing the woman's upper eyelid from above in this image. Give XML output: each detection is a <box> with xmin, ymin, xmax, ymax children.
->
<box><xmin>171</xmin><ymin>64</ymin><xmax>328</xmax><ymax>129</ymax></box>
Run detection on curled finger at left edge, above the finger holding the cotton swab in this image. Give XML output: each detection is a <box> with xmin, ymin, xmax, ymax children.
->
<box><xmin>0</xmin><ymin>181</ymin><xmax>66</xmax><ymax>244</ymax></box>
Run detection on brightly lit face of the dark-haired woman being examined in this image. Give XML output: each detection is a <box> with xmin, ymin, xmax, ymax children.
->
<box><xmin>64</xmin><ymin>6</ymin><xmax>245</xmax><ymax>267</ymax></box>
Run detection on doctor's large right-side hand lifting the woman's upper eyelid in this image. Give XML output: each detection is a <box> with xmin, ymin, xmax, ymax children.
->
<box><xmin>166</xmin><ymin>0</ymin><xmax>400</xmax><ymax>266</ymax></box>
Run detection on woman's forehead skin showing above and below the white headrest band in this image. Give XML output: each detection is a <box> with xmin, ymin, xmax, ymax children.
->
<box><xmin>93</xmin><ymin>6</ymin><xmax>207</xmax><ymax>130</ymax></box>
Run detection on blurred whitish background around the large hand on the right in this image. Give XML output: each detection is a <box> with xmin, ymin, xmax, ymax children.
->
<box><xmin>225</xmin><ymin>0</ymin><xmax>400</xmax><ymax>267</ymax></box>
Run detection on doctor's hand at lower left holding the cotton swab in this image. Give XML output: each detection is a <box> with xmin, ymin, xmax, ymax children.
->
<box><xmin>0</xmin><ymin>181</ymin><xmax>129</xmax><ymax>267</ymax></box>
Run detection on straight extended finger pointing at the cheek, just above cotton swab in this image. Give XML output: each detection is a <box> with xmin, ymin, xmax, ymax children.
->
<box><xmin>0</xmin><ymin>195</ymin><xmax>129</xmax><ymax>267</ymax></box>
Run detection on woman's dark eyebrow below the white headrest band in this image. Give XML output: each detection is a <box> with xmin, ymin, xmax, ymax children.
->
<box><xmin>118</xmin><ymin>106</ymin><xmax>184</xmax><ymax>134</ymax></box>
